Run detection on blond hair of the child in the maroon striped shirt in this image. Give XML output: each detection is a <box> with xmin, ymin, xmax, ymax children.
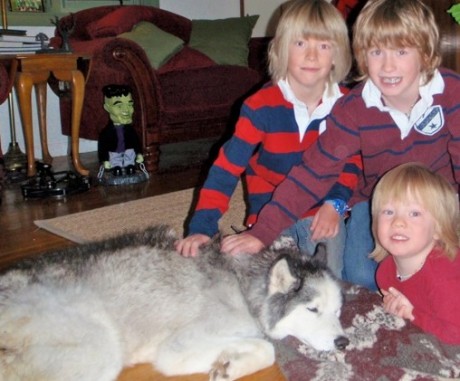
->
<box><xmin>353</xmin><ymin>0</ymin><xmax>441</xmax><ymax>84</ymax></box>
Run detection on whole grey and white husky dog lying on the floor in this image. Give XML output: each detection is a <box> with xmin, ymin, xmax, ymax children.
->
<box><xmin>0</xmin><ymin>226</ymin><xmax>348</xmax><ymax>381</ymax></box>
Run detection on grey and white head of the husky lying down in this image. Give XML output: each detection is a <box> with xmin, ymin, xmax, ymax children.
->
<box><xmin>260</xmin><ymin>255</ymin><xmax>349</xmax><ymax>351</ymax></box>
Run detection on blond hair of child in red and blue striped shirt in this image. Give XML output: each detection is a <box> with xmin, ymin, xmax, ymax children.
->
<box><xmin>268</xmin><ymin>0</ymin><xmax>352</xmax><ymax>84</ymax></box>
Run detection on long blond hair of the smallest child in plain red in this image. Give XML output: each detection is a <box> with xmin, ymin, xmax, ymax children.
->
<box><xmin>370</xmin><ymin>163</ymin><xmax>460</xmax><ymax>261</ymax></box>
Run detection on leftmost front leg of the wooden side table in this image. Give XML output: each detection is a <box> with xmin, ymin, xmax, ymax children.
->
<box><xmin>16</xmin><ymin>73</ymin><xmax>36</xmax><ymax>176</ymax></box>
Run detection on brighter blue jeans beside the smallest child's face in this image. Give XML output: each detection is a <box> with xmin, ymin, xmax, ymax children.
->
<box><xmin>342</xmin><ymin>201</ymin><xmax>377</xmax><ymax>291</ymax></box>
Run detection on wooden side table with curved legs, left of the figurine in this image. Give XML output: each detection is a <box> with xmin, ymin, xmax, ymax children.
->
<box><xmin>15</xmin><ymin>53</ymin><xmax>89</xmax><ymax>176</ymax></box>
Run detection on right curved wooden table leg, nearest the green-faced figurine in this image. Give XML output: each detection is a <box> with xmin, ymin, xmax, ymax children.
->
<box><xmin>71</xmin><ymin>70</ymin><xmax>89</xmax><ymax>176</ymax></box>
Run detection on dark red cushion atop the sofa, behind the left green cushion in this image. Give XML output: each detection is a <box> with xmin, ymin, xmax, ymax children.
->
<box><xmin>87</xmin><ymin>5</ymin><xmax>192</xmax><ymax>42</ymax></box>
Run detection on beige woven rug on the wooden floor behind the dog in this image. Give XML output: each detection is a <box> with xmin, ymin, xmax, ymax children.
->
<box><xmin>34</xmin><ymin>183</ymin><xmax>246</xmax><ymax>243</ymax></box>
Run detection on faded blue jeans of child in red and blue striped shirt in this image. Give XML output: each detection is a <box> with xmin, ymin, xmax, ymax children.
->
<box><xmin>282</xmin><ymin>217</ymin><xmax>346</xmax><ymax>279</ymax></box>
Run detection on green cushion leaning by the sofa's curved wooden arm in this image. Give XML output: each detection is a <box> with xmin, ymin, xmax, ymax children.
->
<box><xmin>117</xmin><ymin>21</ymin><xmax>184</xmax><ymax>69</ymax></box>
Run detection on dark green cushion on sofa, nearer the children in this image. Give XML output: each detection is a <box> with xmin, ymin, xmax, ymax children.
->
<box><xmin>189</xmin><ymin>15</ymin><xmax>259</xmax><ymax>66</ymax></box>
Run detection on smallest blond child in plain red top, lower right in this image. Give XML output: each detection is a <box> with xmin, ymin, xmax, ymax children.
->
<box><xmin>372</xmin><ymin>163</ymin><xmax>460</xmax><ymax>345</ymax></box>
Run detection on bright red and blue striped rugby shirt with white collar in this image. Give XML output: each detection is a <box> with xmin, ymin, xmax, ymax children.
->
<box><xmin>188</xmin><ymin>84</ymin><xmax>361</xmax><ymax>237</ymax></box>
